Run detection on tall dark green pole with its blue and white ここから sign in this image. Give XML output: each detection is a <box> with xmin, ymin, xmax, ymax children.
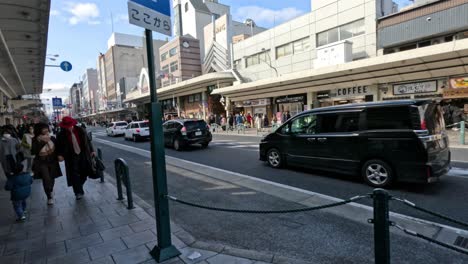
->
<box><xmin>128</xmin><ymin>0</ymin><xmax>180</xmax><ymax>262</ymax></box>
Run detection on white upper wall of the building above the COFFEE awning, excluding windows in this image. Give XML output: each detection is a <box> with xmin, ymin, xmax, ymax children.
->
<box><xmin>233</xmin><ymin>0</ymin><xmax>380</xmax><ymax>81</ymax></box>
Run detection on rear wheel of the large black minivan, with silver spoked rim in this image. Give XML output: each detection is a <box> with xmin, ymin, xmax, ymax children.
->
<box><xmin>362</xmin><ymin>159</ymin><xmax>394</xmax><ymax>188</ymax></box>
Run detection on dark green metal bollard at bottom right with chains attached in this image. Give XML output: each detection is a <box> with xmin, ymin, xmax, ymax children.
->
<box><xmin>370</xmin><ymin>189</ymin><xmax>390</xmax><ymax>264</ymax></box>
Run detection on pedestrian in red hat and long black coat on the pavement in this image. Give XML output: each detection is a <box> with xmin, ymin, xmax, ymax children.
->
<box><xmin>57</xmin><ymin>116</ymin><xmax>96</xmax><ymax>200</ymax></box>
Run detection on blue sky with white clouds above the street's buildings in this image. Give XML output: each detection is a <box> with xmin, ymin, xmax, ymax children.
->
<box><xmin>44</xmin><ymin>0</ymin><xmax>409</xmax><ymax>98</ymax></box>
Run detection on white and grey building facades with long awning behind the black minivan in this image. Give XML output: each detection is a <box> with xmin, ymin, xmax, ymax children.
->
<box><xmin>210</xmin><ymin>0</ymin><xmax>468</xmax><ymax>120</ymax></box>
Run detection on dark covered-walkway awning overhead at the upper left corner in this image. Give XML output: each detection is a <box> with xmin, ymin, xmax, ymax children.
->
<box><xmin>0</xmin><ymin>0</ymin><xmax>50</xmax><ymax>98</ymax></box>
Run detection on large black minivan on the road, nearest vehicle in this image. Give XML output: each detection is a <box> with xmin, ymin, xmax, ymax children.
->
<box><xmin>260</xmin><ymin>100</ymin><xmax>450</xmax><ymax>187</ymax></box>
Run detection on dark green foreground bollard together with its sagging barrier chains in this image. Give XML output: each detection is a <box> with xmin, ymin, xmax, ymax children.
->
<box><xmin>166</xmin><ymin>189</ymin><xmax>468</xmax><ymax>264</ymax></box>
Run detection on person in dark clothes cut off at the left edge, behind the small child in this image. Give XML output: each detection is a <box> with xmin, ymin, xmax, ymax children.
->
<box><xmin>0</xmin><ymin>127</ymin><xmax>20</xmax><ymax>177</ymax></box>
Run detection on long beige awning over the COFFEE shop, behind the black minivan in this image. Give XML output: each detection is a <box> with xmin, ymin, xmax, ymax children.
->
<box><xmin>213</xmin><ymin>39</ymin><xmax>468</xmax><ymax>101</ymax></box>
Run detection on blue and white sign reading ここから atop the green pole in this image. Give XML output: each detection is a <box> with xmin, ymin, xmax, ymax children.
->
<box><xmin>128</xmin><ymin>0</ymin><xmax>172</xmax><ymax>36</ymax></box>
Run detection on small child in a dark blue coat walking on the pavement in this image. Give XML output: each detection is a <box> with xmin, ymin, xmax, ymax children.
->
<box><xmin>5</xmin><ymin>163</ymin><xmax>33</xmax><ymax>222</ymax></box>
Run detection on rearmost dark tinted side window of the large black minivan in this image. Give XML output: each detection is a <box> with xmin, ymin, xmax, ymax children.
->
<box><xmin>367</xmin><ymin>106</ymin><xmax>413</xmax><ymax>130</ymax></box>
